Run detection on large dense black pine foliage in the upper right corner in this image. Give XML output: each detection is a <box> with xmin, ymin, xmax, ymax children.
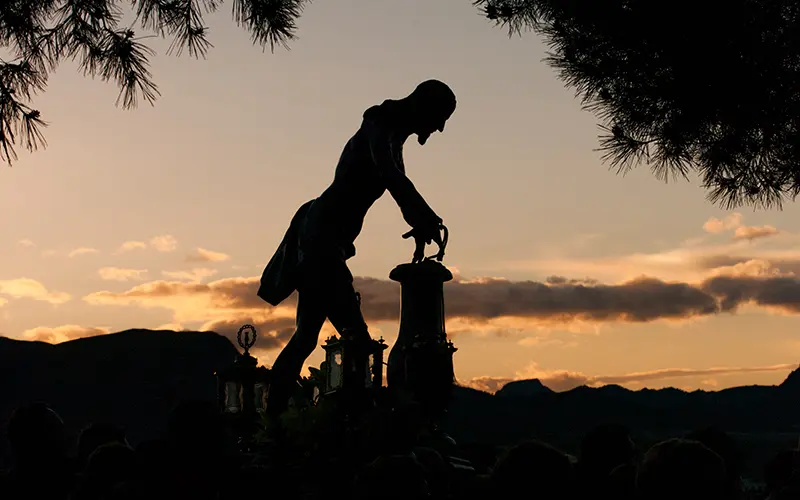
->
<box><xmin>474</xmin><ymin>0</ymin><xmax>800</xmax><ymax>208</ymax></box>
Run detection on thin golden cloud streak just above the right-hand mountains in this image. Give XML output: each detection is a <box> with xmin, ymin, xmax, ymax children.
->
<box><xmin>460</xmin><ymin>363</ymin><xmax>798</xmax><ymax>393</ymax></box>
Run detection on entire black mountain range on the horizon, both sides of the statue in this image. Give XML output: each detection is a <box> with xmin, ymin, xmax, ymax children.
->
<box><xmin>0</xmin><ymin>330</ymin><xmax>800</xmax><ymax>478</ymax></box>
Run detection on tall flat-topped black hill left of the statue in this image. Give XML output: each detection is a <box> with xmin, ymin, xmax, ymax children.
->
<box><xmin>0</xmin><ymin>330</ymin><xmax>237</xmax><ymax>468</ymax></box>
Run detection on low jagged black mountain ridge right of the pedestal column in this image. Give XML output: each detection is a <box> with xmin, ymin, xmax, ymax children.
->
<box><xmin>447</xmin><ymin>369</ymin><xmax>800</xmax><ymax>442</ymax></box>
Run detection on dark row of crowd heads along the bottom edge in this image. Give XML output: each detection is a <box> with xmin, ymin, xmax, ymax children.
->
<box><xmin>0</xmin><ymin>402</ymin><xmax>800</xmax><ymax>500</ymax></box>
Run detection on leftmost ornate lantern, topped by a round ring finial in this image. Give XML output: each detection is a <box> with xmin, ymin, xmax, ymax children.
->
<box><xmin>216</xmin><ymin>325</ymin><xmax>270</xmax><ymax>418</ymax></box>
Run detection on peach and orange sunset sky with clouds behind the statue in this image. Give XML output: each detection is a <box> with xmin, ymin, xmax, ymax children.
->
<box><xmin>0</xmin><ymin>0</ymin><xmax>800</xmax><ymax>390</ymax></box>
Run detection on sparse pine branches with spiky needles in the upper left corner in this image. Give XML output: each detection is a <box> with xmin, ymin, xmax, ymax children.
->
<box><xmin>0</xmin><ymin>0</ymin><xmax>310</xmax><ymax>165</ymax></box>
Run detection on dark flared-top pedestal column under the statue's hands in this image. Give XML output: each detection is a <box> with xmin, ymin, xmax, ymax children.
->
<box><xmin>386</xmin><ymin>238</ymin><xmax>456</xmax><ymax>417</ymax></box>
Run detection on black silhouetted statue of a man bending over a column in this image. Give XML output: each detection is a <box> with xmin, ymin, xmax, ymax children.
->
<box><xmin>258</xmin><ymin>80</ymin><xmax>456</xmax><ymax>415</ymax></box>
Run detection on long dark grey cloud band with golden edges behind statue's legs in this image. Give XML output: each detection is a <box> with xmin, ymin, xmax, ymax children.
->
<box><xmin>79</xmin><ymin>267</ymin><xmax>800</xmax><ymax>347</ymax></box>
